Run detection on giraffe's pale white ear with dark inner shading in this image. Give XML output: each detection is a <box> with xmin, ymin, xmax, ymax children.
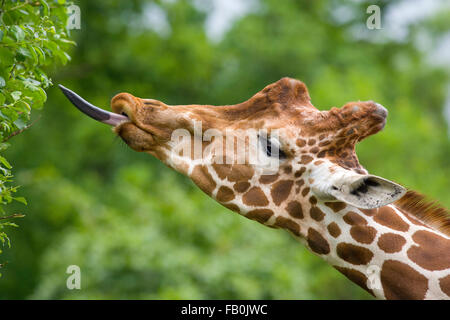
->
<box><xmin>329</xmin><ymin>174</ymin><xmax>406</xmax><ymax>209</ymax></box>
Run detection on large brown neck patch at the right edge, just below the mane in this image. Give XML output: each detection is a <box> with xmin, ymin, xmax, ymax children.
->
<box><xmin>408</xmin><ymin>230</ymin><xmax>450</xmax><ymax>270</ymax></box>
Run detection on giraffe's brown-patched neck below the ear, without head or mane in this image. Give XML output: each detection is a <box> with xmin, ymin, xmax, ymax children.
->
<box><xmin>310</xmin><ymin>202</ymin><xmax>450</xmax><ymax>299</ymax></box>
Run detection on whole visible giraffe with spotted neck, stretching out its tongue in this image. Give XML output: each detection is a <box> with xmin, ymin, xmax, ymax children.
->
<box><xmin>60</xmin><ymin>78</ymin><xmax>450</xmax><ymax>299</ymax></box>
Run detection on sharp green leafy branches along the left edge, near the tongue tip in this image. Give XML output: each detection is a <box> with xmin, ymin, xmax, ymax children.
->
<box><xmin>0</xmin><ymin>0</ymin><xmax>74</xmax><ymax>276</ymax></box>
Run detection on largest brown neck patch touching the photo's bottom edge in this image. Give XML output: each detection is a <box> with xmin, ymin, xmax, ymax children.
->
<box><xmin>380</xmin><ymin>260</ymin><xmax>428</xmax><ymax>300</ymax></box>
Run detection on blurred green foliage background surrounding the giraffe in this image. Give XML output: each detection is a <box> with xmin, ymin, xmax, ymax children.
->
<box><xmin>0</xmin><ymin>0</ymin><xmax>450</xmax><ymax>299</ymax></box>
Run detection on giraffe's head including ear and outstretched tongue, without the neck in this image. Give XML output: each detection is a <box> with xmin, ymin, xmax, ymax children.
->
<box><xmin>58</xmin><ymin>78</ymin><xmax>405</xmax><ymax>234</ymax></box>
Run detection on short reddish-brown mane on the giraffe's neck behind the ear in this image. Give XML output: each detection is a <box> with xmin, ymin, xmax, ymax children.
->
<box><xmin>394</xmin><ymin>190</ymin><xmax>450</xmax><ymax>236</ymax></box>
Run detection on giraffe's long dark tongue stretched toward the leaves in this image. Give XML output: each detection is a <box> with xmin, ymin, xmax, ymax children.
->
<box><xmin>58</xmin><ymin>85</ymin><xmax>129</xmax><ymax>126</ymax></box>
